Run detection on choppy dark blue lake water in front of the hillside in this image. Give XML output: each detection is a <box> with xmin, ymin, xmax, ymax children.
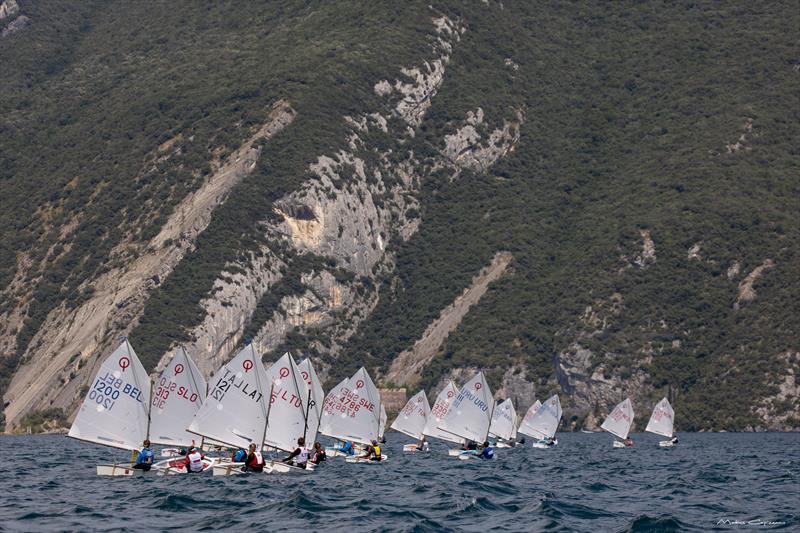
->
<box><xmin>0</xmin><ymin>432</ymin><xmax>800</xmax><ymax>532</ymax></box>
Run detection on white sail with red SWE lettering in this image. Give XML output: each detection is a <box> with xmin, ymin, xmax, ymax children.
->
<box><xmin>322</xmin><ymin>367</ymin><xmax>381</xmax><ymax>444</ymax></box>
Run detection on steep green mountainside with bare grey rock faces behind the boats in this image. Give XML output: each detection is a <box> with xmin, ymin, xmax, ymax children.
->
<box><xmin>0</xmin><ymin>0</ymin><xmax>800</xmax><ymax>430</ymax></box>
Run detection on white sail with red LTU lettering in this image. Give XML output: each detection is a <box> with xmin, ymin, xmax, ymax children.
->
<box><xmin>264</xmin><ymin>353</ymin><xmax>309</xmax><ymax>452</ymax></box>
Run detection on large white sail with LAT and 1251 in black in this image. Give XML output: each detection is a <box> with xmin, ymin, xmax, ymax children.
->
<box><xmin>188</xmin><ymin>344</ymin><xmax>269</xmax><ymax>448</ymax></box>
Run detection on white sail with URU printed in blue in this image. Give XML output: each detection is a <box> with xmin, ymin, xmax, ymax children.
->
<box><xmin>439</xmin><ymin>372</ymin><xmax>494</xmax><ymax>442</ymax></box>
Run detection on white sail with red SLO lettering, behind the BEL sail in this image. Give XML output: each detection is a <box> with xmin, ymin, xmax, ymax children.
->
<box><xmin>150</xmin><ymin>346</ymin><xmax>206</xmax><ymax>446</ymax></box>
